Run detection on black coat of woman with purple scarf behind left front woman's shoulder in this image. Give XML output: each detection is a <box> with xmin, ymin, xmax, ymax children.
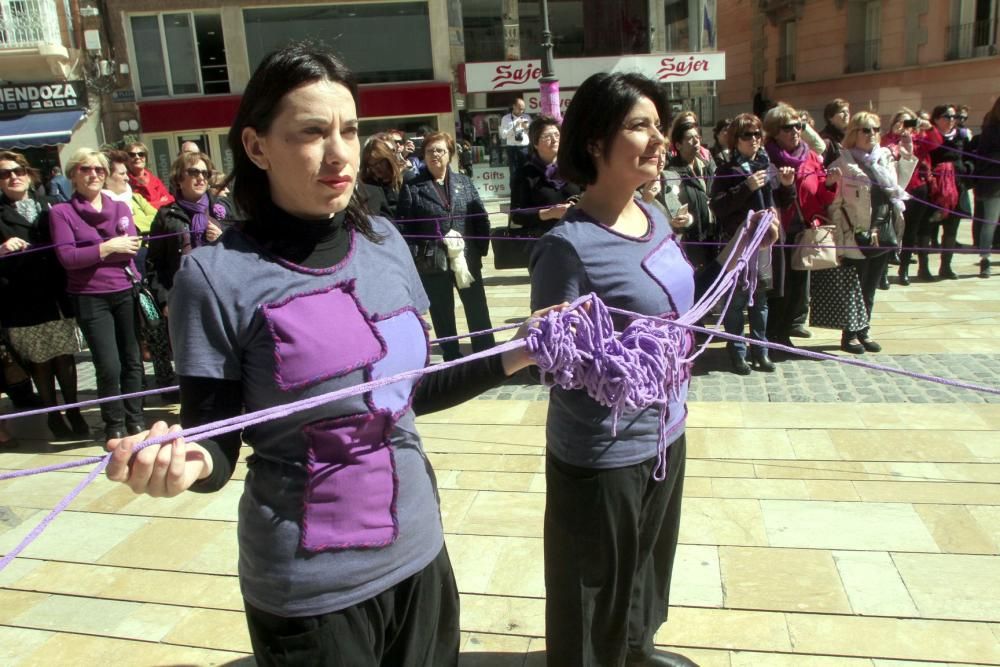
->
<box><xmin>145</xmin><ymin>195</ymin><xmax>228</xmax><ymax>307</ymax></box>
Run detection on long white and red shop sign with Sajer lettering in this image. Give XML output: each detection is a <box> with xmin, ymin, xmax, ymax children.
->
<box><xmin>465</xmin><ymin>52</ymin><xmax>726</xmax><ymax>93</ymax></box>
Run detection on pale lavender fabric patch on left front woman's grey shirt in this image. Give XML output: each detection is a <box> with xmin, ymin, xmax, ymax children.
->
<box><xmin>371</xmin><ymin>308</ymin><xmax>430</xmax><ymax>416</ymax></box>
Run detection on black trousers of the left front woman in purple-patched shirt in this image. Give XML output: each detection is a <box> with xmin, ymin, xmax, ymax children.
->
<box><xmin>244</xmin><ymin>548</ymin><xmax>460</xmax><ymax>667</ymax></box>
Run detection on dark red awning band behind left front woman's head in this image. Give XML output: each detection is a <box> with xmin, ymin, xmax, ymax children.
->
<box><xmin>138</xmin><ymin>81</ymin><xmax>452</xmax><ymax>132</ymax></box>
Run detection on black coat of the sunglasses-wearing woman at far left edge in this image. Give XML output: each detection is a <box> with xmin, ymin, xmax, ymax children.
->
<box><xmin>0</xmin><ymin>195</ymin><xmax>74</xmax><ymax>327</ymax></box>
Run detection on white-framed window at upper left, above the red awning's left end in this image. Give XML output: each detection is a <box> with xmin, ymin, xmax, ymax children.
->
<box><xmin>129</xmin><ymin>12</ymin><xmax>229</xmax><ymax>97</ymax></box>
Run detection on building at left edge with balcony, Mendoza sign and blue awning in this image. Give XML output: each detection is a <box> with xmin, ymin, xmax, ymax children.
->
<box><xmin>0</xmin><ymin>0</ymin><xmax>104</xmax><ymax>173</ymax></box>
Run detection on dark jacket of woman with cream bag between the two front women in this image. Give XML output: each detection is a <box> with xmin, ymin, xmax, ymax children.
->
<box><xmin>396</xmin><ymin>167</ymin><xmax>490</xmax><ymax>273</ymax></box>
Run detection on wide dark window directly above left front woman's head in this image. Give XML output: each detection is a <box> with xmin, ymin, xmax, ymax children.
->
<box><xmin>243</xmin><ymin>2</ymin><xmax>434</xmax><ymax>83</ymax></box>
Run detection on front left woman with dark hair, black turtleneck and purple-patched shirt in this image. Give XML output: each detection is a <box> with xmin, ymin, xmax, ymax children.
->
<box><xmin>107</xmin><ymin>45</ymin><xmax>552</xmax><ymax>667</ymax></box>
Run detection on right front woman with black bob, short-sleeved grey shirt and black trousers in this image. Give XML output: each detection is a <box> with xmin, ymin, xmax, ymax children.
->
<box><xmin>531</xmin><ymin>72</ymin><xmax>777</xmax><ymax>666</ymax></box>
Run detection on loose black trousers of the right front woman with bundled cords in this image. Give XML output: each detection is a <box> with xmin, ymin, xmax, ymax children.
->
<box><xmin>545</xmin><ymin>436</ymin><xmax>685</xmax><ymax>667</ymax></box>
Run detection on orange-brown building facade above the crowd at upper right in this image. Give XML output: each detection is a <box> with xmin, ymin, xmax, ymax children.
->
<box><xmin>718</xmin><ymin>0</ymin><xmax>1000</xmax><ymax>127</ymax></box>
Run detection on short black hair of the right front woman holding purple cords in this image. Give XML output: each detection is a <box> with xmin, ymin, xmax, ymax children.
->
<box><xmin>558</xmin><ymin>72</ymin><xmax>668</xmax><ymax>186</ymax></box>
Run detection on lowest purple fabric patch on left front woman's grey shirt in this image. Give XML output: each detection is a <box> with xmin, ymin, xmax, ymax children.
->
<box><xmin>301</xmin><ymin>412</ymin><xmax>399</xmax><ymax>551</ymax></box>
